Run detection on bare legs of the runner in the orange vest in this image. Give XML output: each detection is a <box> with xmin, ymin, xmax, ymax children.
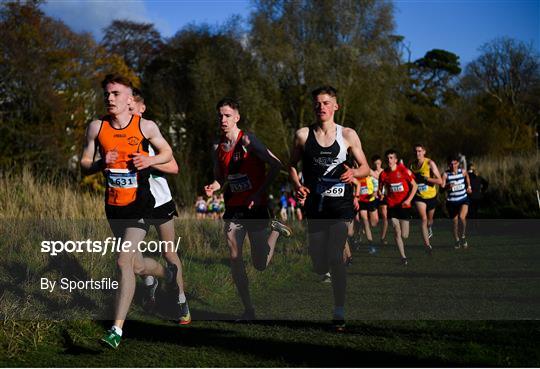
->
<box><xmin>114</xmin><ymin>228</ymin><xmax>165</xmax><ymax>328</ymax></box>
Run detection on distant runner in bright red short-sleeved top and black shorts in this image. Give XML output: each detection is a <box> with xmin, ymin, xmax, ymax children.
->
<box><xmin>379</xmin><ymin>150</ymin><xmax>418</xmax><ymax>265</ymax></box>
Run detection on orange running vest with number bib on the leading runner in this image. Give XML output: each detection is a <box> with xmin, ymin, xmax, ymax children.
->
<box><xmin>98</xmin><ymin>115</ymin><xmax>149</xmax><ymax>206</ymax></box>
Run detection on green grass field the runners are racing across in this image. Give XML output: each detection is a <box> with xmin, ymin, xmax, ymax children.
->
<box><xmin>0</xmin><ymin>219</ymin><xmax>540</xmax><ymax>367</ymax></box>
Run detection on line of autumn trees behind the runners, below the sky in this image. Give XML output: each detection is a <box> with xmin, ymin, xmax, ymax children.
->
<box><xmin>0</xmin><ymin>0</ymin><xmax>540</xmax><ymax>203</ymax></box>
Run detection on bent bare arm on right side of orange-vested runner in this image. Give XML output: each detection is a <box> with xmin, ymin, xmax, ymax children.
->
<box><xmin>133</xmin><ymin>118</ymin><xmax>173</xmax><ymax>170</ymax></box>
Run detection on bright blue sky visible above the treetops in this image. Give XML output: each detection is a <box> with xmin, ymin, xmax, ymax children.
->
<box><xmin>42</xmin><ymin>0</ymin><xmax>540</xmax><ymax>65</ymax></box>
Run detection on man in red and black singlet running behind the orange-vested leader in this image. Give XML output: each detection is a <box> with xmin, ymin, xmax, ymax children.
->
<box><xmin>204</xmin><ymin>98</ymin><xmax>291</xmax><ymax>321</ymax></box>
